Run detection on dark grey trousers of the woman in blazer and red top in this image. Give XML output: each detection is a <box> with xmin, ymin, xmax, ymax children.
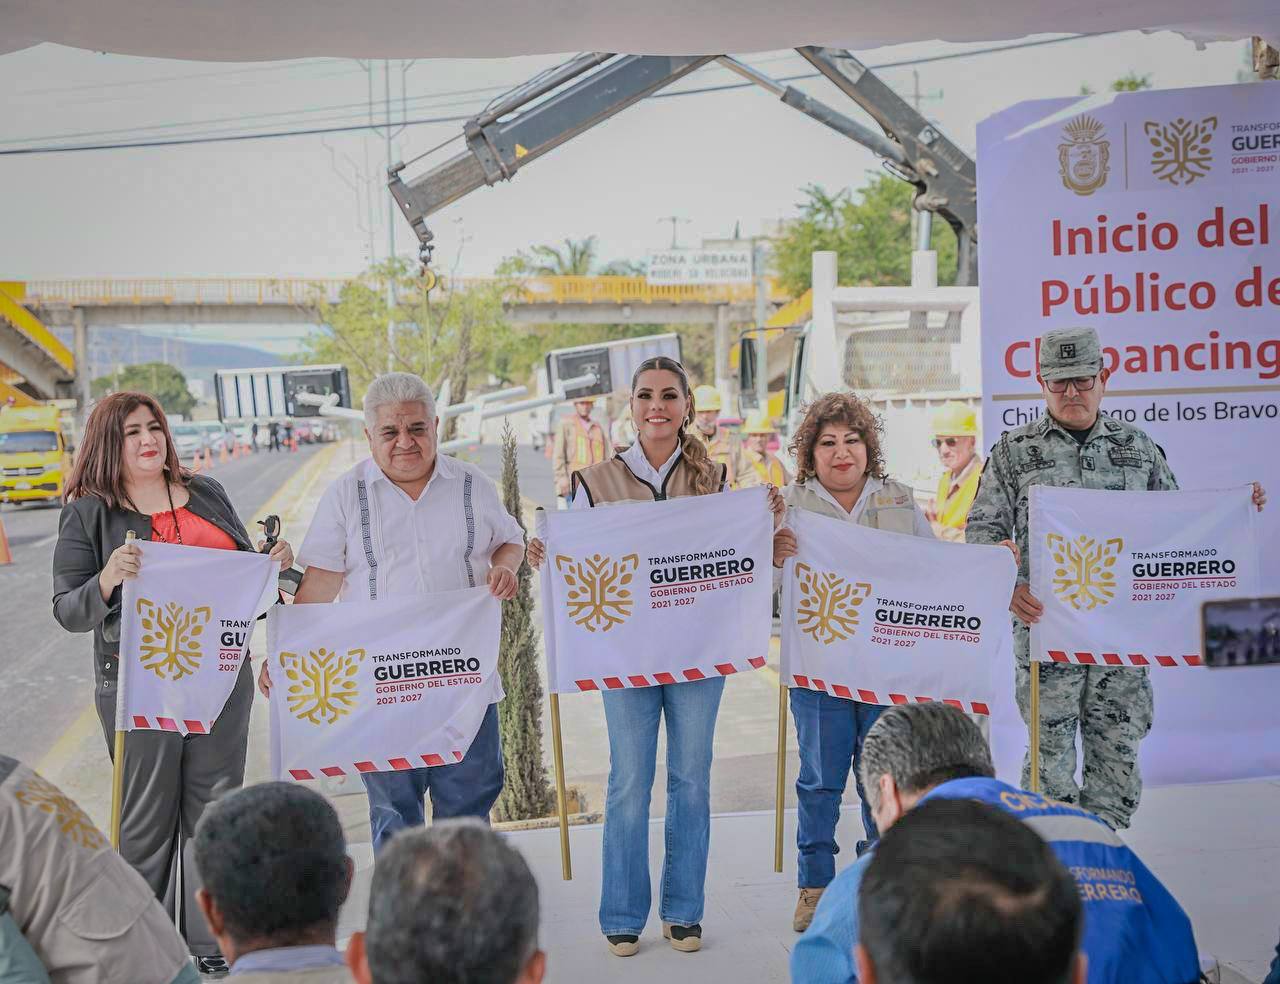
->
<box><xmin>95</xmin><ymin>659</ymin><xmax>253</xmax><ymax>957</ymax></box>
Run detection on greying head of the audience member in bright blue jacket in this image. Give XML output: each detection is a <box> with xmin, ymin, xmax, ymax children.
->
<box><xmin>863</xmin><ymin>701</ymin><xmax>996</xmax><ymax>830</ymax></box>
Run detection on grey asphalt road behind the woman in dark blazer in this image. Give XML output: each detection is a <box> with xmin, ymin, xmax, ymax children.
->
<box><xmin>0</xmin><ymin>445</ymin><xmax>320</xmax><ymax>764</ymax></box>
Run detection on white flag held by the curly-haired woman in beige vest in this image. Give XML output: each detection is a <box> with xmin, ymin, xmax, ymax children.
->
<box><xmin>782</xmin><ymin>512</ymin><xmax>1016</xmax><ymax>714</ymax></box>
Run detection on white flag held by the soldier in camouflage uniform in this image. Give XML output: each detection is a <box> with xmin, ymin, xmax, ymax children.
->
<box><xmin>1029</xmin><ymin>485</ymin><xmax>1258</xmax><ymax>667</ymax></box>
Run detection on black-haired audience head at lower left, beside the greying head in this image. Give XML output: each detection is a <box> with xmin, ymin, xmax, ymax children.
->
<box><xmin>195</xmin><ymin>782</ymin><xmax>353</xmax><ymax>964</ymax></box>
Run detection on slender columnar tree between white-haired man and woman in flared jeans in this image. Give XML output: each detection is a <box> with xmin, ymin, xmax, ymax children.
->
<box><xmin>494</xmin><ymin>424</ymin><xmax>554</xmax><ymax>820</ymax></box>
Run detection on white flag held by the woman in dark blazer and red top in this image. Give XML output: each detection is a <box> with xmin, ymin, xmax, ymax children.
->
<box><xmin>115</xmin><ymin>540</ymin><xmax>278</xmax><ymax>734</ymax></box>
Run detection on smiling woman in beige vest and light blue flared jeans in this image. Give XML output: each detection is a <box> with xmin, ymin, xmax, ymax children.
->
<box><xmin>529</xmin><ymin>357</ymin><xmax>783</xmax><ymax>957</ymax></box>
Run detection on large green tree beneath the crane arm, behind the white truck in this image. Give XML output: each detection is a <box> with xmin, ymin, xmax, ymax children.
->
<box><xmin>773</xmin><ymin>173</ymin><xmax>956</xmax><ymax>297</ymax></box>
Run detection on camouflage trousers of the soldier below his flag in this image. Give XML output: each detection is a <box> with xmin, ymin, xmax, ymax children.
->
<box><xmin>1014</xmin><ymin>619</ymin><xmax>1153</xmax><ymax>830</ymax></box>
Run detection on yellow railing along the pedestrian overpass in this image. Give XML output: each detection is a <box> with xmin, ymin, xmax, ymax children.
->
<box><xmin>26</xmin><ymin>276</ymin><xmax>788</xmax><ymax>307</ymax></box>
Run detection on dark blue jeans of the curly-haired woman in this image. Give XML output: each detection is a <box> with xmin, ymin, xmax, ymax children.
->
<box><xmin>791</xmin><ymin>687</ymin><xmax>883</xmax><ymax>888</ymax></box>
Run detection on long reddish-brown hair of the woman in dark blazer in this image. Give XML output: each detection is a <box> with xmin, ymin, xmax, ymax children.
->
<box><xmin>64</xmin><ymin>393</ymin><xmax>191</xmax><ymax>509</ymax></box>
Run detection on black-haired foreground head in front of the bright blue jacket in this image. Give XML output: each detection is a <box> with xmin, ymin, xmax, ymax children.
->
<box><xmin>854</xmin><ymin>800</ymin><xmax>1087</xmax><ymax>984</ymax></box>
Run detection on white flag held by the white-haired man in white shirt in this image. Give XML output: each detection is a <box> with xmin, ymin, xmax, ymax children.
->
<box><xmin>266</xmin><ymin>585</ymin><xmax>503</xmax><ymax>779</ymax></box>
